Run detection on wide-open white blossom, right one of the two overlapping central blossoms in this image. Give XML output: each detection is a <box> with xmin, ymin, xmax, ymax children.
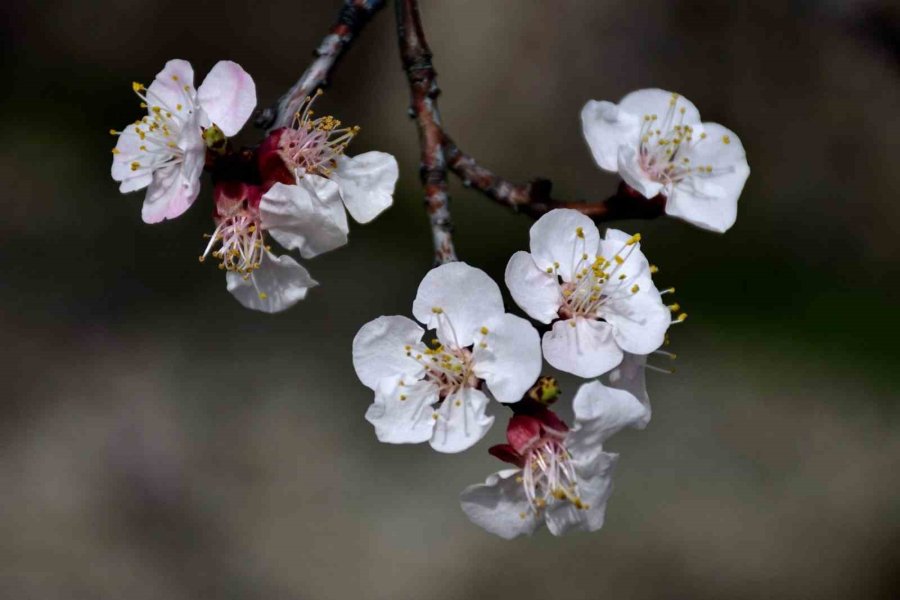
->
<box><xmin>506</xmin><ymin>209</ymin><xmax>672</xmax><ymax>377</ymax></box>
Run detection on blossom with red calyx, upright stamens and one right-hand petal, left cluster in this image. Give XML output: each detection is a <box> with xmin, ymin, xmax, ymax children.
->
<box><xmin>261</xmin><ymin>91</ymin><xmax>399</xmax><ymax>229</ymax></box>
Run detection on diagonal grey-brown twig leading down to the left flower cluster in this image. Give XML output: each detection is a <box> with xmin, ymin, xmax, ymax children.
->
<box><xmin>254</xmin><ymin>0</ymin><xmax>385</xmax><ymax>129</ymax></box>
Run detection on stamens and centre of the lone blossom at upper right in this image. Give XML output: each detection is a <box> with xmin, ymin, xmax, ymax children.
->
<box><xmin>638</xmin><ymin>94</ymin><xmax>713</xmax><ymax>186</ymax></box>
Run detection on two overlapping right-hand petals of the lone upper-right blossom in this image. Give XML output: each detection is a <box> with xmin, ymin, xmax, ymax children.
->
<box><xmin>666</xmin><ymin>123</ymin><xmax>750</xmax><ymax>233</ymax></box>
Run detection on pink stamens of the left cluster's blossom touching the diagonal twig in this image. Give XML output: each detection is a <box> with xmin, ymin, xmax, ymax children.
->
<box><xmin>278</xmin><ymin>90</ymin><xmax>359</xmax><ymax>177</ymax></box>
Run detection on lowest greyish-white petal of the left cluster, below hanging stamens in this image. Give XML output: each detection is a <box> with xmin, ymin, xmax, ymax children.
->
<box><xmin>225</xmin><ymin>252</ymin><xmax>319</xmax><ymax>313</ymax></box>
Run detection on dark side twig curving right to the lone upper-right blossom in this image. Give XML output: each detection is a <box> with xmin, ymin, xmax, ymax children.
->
<box><xmin>443</xmin><ymin>134</ymin><xmax>666</xmax><ymax>223</ymax></box>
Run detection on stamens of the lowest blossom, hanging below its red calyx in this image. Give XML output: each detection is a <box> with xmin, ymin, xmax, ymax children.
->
<box><xmin>517</xmin><ymin>435</ymin><xmax>590</xmax><ymax>512</ymax></box>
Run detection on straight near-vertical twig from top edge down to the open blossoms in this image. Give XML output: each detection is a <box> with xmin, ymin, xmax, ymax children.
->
<box><xmin>396</xmin><ymin>0</ymin><xmax>457</xmax><ymax>264</ymax></box>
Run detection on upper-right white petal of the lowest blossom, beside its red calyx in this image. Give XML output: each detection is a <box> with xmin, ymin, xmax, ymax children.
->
<box><xmin>566</xmin><ymin>381</ymin><xmax>647</xmax><ymax>460</ymax></box>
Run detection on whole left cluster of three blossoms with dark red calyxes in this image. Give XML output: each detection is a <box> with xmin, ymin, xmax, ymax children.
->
<box><xmin>112</xmin><ymin>60</ymin><xmax>398</xmax><ymax>313</ymax></box>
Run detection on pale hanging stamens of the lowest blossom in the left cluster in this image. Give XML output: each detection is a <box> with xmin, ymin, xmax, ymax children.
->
<box><xmin>200</xmin><ymin>203</ymin><xmax>269</xmax><ymax>279</ymax></box>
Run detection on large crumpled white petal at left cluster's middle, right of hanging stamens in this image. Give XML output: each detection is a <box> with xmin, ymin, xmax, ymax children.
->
<box><xmin>259</xmin><ymin>175</ymin><xmax>348</xmax><ymax>258</ymax></box>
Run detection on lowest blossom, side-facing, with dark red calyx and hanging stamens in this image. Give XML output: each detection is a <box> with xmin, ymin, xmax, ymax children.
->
<box><xmin>460</xmin><ymin>381</ymin><xmax>646</xmax><ymax>539</ymax></box>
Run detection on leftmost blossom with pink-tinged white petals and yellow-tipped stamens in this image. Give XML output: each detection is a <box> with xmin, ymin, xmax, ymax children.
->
<box><xmin>112</xmin><ymin>59</ymin><xmax>256</xmax><ymax>223</ymax></box>
